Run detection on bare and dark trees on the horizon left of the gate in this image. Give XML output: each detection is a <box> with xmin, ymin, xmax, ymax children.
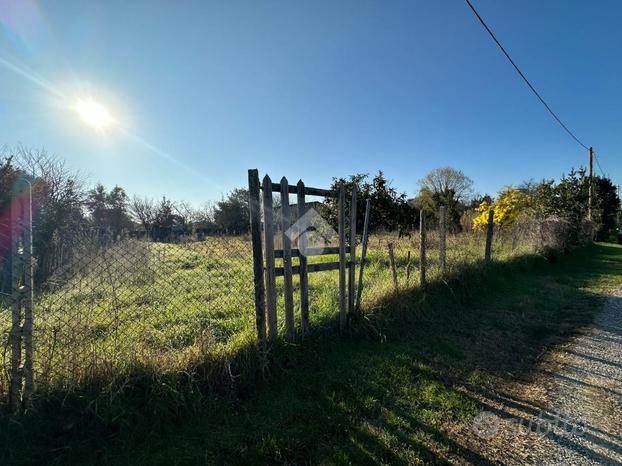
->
<box><xmin>0</xmin><ymin>147</ymin><xmax>249</xmax><ymax>291</ymax></box>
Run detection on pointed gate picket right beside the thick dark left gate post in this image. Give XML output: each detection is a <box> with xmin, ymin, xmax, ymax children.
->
<box><xmin>263</xmin><ymin>175</ymin><xmax>278</xmax><ymax>340</ymax></box>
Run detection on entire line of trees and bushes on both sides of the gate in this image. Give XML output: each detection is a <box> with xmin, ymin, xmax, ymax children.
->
<box><xmin>0</xmin><ymin>147</ymin><xmax>620</xmax><ymax>285</ymax></box>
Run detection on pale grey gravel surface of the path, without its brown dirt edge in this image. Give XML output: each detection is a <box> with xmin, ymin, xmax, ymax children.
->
<box><xmin>534</xmin><ymin>293</ymin><xmax>622</xmax><ymax>465</ymax></box>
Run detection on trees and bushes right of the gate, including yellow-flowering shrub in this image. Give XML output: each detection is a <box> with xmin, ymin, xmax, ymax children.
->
<box><xmin>322</xmin><ymin>167</ymin><xmax>620</xmax><ymax>245</ymax></box>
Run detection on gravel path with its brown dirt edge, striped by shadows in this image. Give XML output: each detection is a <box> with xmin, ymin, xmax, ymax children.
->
<box><xmin>458</xmin><ymin>290</ymin><xmax>622</xmax><ymax>465</ymax></box>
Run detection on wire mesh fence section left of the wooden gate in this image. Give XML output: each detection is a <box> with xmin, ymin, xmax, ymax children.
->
<box><xmin>0</xmin><ymin>227</ymin><xmax>253</xmax><ymax>400</ymax></box>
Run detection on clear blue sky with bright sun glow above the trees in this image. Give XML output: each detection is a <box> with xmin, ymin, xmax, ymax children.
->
<box><xmin>0</xmin><ymin>0</ymin><xmax>622</xmax><ymax>204</ymax></box>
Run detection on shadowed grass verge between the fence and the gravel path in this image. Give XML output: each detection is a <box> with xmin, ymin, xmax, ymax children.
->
<box><xmin>0</xmin><ymin>244</ymin><xmax>622</xmax><ymax>464</ymax></box>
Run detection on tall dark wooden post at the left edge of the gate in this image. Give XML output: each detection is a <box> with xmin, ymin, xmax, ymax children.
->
<box><xmin>248</xmin><ymin>169</ymin><xmax>266</xmax><ymax>370</ymax></box>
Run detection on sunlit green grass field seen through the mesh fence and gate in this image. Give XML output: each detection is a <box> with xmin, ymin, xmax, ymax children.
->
<box><xmin>0</xmin><ymin>203</ymin><xmax>560</xmax><ymax>404</ymax></box>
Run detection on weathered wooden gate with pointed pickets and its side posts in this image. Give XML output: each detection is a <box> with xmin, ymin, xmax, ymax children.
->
<box><xmin>248</xmin><ymin>169</ymin><xmax>369</xmax><ymax>353</ymax></box>
